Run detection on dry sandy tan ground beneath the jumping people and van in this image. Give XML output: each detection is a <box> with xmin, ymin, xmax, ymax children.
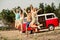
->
<box><xmin>0</xmin><ymin>27</ymin><xmax>60</xmax><ymax>40</ymax></box>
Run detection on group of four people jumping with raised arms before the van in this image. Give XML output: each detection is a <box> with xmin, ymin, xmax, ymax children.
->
<box><xmin>13</xmin><ymin>5</ymin><xmax>41</xmax><ymax>33</ymax></box>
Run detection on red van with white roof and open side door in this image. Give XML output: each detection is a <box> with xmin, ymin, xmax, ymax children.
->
<box><xmin>17</xmin><ymin>13</ymin><xmax>59</xmax><ymax>32</ymax></box>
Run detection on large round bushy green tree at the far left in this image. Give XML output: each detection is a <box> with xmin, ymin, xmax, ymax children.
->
<box><xmin>1</xmin><ymin>9</ymin><xmax>15</xmax><ymax>27</ymax></box>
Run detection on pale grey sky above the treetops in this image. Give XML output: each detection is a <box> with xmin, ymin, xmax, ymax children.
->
<box><xmin>0</xmin><ymin>0</ymin><xmax>60</xmax><ymax>11</ymax></box>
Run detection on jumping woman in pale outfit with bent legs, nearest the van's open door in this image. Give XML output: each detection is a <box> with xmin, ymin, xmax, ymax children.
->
<box><xmin>30</xmin><ymin>8</ymin><xmax>41</xmax><ymax>31</ymax></box>
